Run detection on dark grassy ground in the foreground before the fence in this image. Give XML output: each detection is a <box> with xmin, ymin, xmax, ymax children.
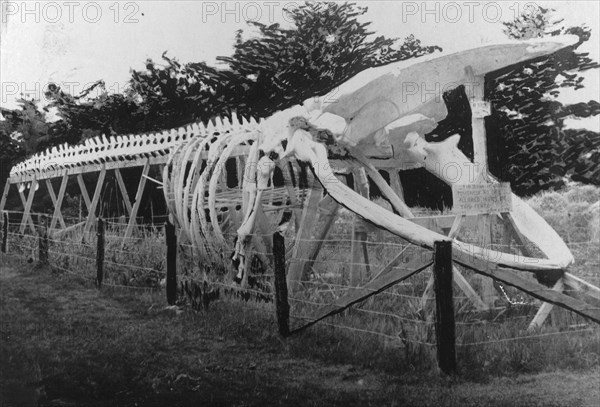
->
<box><xmin>0</xmin><ymin>256</ymin><xmax>600</xmax><ymax>407</ymax></box>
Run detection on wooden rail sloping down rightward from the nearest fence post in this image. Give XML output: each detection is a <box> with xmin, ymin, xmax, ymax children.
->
<box><xmin>454</xmin><ymin>257</ymin><xmax>600</xmax><ymax>323</ymax></box>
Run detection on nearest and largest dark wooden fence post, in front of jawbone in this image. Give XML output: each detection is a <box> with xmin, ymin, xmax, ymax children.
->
<box><xmin>433</xmin><ymin>241</ymin><xmax>456</xmax><ymax>375</ymax></box>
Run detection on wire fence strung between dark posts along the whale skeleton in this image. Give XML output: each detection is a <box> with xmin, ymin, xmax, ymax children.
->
<box><xmin>1</xmin><ymin>212</ymin><xmax>600</xmax><ymax>370</ymax></box>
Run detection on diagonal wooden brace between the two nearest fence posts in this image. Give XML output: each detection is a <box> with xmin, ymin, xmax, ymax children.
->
<box><xmin>291</xmin><ymin>253</ymin><xmax>433</xmax><ymax>333</ymax></box>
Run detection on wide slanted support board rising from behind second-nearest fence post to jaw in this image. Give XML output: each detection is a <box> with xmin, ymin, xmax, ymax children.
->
<box><xmin>287</xmin><ymin>181</ymin><xmax>323</xmax><ymax>293</ymax></box>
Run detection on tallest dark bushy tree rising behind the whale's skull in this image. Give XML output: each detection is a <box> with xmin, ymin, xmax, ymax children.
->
<box><xmin>218</xmin><ymin>2</ymin><xmax>441</xmax><ymax>117</ymax></box>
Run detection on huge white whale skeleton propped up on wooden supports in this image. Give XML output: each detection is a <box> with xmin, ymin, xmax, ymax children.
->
<box><xmin>0</xmin><ymin>37</ymin><xmax>600</xmax><ymax>327</ymax></box>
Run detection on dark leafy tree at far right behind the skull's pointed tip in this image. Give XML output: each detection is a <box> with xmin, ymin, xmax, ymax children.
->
<box><xmin>486</xmin><ymin>7</ymin><xmax>600</xmax><ymax>195</ymax></box>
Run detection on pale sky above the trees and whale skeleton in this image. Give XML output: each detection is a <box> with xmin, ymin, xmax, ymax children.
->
<box><xmin>0</xmin><ymin>0</ymin><xmax>600</xmax><ymax>131</ymax></box>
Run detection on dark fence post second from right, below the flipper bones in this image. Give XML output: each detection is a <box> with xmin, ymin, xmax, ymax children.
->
<box><xmin>273</xmin><ymin>232</ymin><xmax>290</xmax><ymax>337</ymax></box>
